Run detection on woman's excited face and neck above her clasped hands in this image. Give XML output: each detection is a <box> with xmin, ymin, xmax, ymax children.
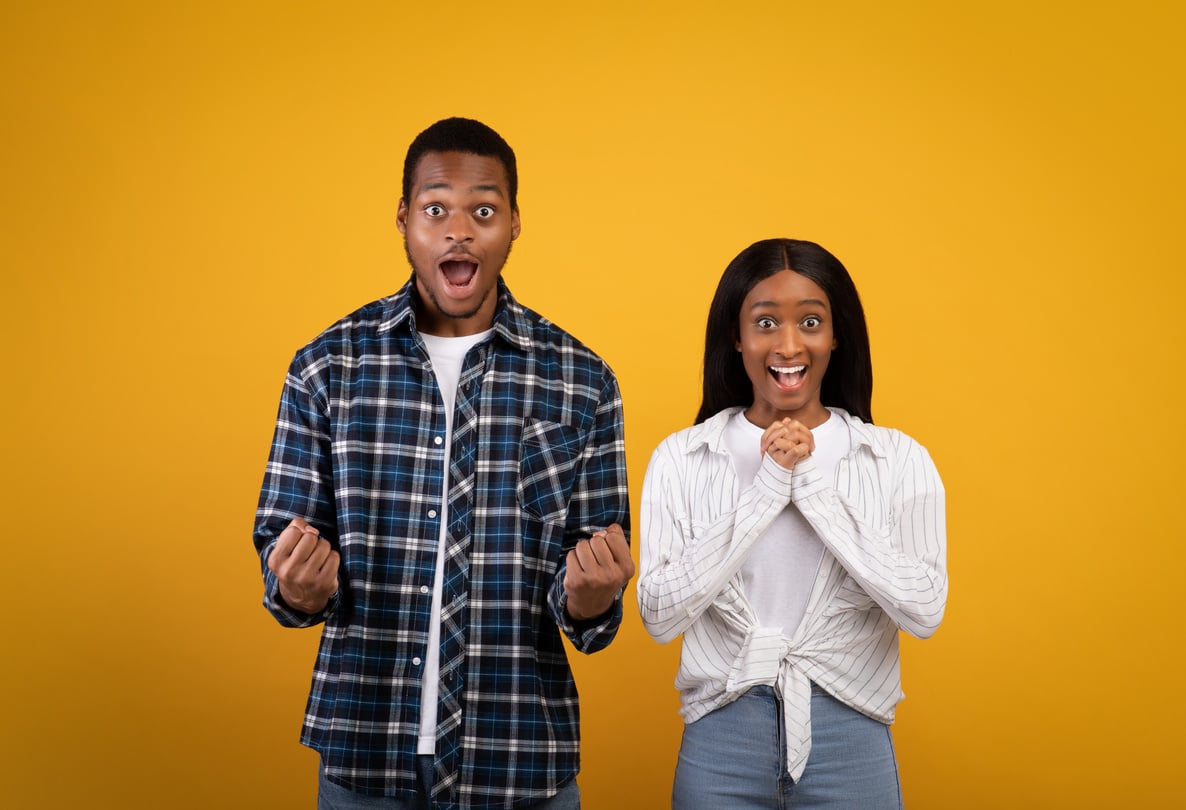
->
<box><xmin>737</xmin><ymin>269</ymin><xmax>836</xmax><ymax>428</ymax></box>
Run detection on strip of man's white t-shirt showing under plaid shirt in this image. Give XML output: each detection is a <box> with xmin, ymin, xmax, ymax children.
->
<box><xmin>416</xmin><ymin>330</ymin><xmax>493</xmax><ymax>754</ymax></box>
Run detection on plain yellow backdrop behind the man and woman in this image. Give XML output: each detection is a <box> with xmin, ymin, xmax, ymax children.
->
<box><xmin>0</xmin><ymin>0</ymin><xmax>1186</xmax><ymax>810</ymax></box>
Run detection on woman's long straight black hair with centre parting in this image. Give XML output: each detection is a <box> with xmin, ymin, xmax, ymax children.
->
<box><xmin>696</xmin><ymin>240</ymin><xmax>873</xmax><ymax>425</ymax></box>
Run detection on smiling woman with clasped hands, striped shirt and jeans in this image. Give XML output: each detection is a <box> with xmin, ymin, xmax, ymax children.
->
<box><xmin>638</xmin><ymin>240</ymin><xmax>948</xmax><ymax>810</ymax></box>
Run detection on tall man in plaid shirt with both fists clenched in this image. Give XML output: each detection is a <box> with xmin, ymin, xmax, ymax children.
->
<box><xmin>255</xmin><ymin>119</ymin><xmax>635</xmax><ymax>810</ymax></box>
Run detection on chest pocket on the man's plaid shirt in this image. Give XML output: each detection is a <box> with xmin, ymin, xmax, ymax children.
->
<box><xmin>518</xmin><ymin>420</ymin><xmax>585</xmax><ymax>522</ymax></box>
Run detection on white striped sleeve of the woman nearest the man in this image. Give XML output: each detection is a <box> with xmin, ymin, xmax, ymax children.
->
<box><xmin>638</xmin><ymin>436</ymin><xmax>791</xmax><ymax>644</ymax></box>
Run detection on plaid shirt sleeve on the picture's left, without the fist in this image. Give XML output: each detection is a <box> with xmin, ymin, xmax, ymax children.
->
<box><xmin>254</xmin><ymin>356</ymin><xmax>340</xmax><ymax>627</ymax></box>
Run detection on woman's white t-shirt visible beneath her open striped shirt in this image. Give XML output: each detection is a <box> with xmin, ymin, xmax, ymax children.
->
<box><xmin>725</xmin><ymin>410</ymin><xmax>850</xmax><ymax>636</ymax></box>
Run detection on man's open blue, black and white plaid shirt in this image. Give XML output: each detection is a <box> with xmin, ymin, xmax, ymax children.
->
<box><xmin>255</xmin><ymin>281</ymin><xmax>629</xmax><ymax>808</ymax></box>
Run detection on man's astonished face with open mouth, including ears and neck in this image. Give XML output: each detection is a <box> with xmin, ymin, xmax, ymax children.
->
<box><xmin>396</xmin><ymin>152</ymin><xmax>519</xmax><ymax>337</ymax></box>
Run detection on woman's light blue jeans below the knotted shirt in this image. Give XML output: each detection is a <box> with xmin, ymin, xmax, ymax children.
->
<box><xmin>671</xmin><ymin>687</ymin><xmax>901</xmax><ymax>810</ymax></box>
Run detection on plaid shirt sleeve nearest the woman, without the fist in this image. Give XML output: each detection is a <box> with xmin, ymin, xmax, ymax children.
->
<box><xmin>548</xmin><ymin>376</ymin><xmax>630</xmax><ymax>653</ymax></box>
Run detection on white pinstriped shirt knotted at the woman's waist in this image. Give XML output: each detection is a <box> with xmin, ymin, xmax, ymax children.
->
<box><xmin>638</xmin><ymin>408</ymin><xmax>948</xmax><ymax>779</ymax></box>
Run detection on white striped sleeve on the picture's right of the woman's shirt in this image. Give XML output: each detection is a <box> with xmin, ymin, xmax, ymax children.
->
<box><xmin>791</xmin><ymin>430</ymin><xmax>948</xmax><ymax>638</ymax></box>
